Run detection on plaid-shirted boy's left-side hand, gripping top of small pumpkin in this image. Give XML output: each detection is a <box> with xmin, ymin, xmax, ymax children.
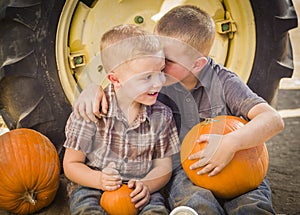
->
<box><xmin>100</xmin><ymin>162</ymin><xmax>122</xmax><ymax>191</ymax></box>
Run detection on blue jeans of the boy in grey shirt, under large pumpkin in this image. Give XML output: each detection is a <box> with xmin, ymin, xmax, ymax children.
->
<box><xmin>163</xmin><ymin>167</ymin><xmax>275</xmax><ymax>215</ymax></box>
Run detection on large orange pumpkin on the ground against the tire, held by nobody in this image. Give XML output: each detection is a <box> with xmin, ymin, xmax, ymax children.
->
<box><xmin>0</xmin><ymin>128</ymin><xmax>60</xmax><ymax>214</ymax></box>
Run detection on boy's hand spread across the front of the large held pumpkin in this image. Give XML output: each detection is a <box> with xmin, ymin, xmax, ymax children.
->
<box><xmin>189</xmin><ymin>134</ymin><xmax>235</xmax><ymax>176</ymax></box>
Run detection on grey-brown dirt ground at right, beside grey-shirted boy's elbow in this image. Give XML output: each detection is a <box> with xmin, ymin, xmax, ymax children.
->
<box><xmin>267</xmin><ymin>90</ymin><xmax>300</xmax><ymax>215</ymax></box>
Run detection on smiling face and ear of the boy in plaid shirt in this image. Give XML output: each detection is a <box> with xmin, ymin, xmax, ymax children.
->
<box><xmin>108</xmin><ymin>54</ymin><xmax>165</xmax><ymax>105</ymax></box>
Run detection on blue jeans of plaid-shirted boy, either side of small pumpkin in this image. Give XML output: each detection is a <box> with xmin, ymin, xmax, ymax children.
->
<box><xmin>69</xmin><ymin>186</ymin><xmax>169</xmax><ymax>215</ymax></box>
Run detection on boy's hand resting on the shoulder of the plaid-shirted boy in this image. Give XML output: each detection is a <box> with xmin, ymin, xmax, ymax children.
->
<box><xmin>74</xmin><ymin>83</ymin><xmax>108</xmax><ymax>122</ymax></box>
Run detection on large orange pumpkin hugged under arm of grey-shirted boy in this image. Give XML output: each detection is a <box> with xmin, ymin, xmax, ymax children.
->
<box><xmin>180</xmin><ymin>116</ymin><xmax>268</xmax><ymax>199</ymax></box>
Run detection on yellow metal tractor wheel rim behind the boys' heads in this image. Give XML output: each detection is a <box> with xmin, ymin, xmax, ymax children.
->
<box><xmin>56</xmin><ymin>0</ymin><xmax>256</xmax><ymax>104</ymax></box>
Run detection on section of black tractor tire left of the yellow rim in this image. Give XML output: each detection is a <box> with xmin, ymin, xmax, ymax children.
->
<box><xmin>0</xmin><ymin>0</ymin><xmax>72</xmax><ymax>163</ymax></box>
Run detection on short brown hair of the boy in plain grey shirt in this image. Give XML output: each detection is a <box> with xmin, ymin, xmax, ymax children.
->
<box><xmin>155</xmin><ymin>5</ymin><xmax>215</xmax><ymax>56</ymax></box>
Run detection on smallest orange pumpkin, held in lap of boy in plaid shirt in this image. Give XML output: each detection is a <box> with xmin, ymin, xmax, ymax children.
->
<box><xmin>100</xmin><ymin>184</ymin><xmax>139</xmax><ymax>215</ymax></box>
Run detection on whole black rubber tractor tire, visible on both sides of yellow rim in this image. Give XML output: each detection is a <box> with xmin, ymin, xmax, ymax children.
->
<box><xmin>0</xmin><ymin>0</ymin><xmax>297</xmax><ymax>161</ymax></box>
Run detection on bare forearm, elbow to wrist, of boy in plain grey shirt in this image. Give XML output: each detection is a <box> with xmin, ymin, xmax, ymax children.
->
<box><xmin>228</xmin><ymin>103</ymin><xmax>284</xmax><ymax>151</ymax></box>
